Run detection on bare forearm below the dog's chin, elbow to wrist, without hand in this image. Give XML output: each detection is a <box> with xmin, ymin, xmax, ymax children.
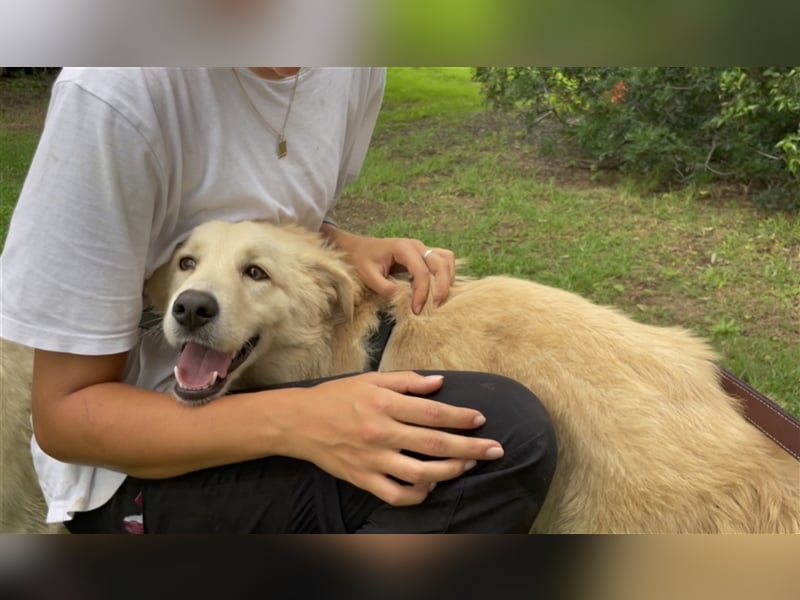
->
<box><xmin>34</xmin><ymin>383</ymin><xmax>298</xmax><ymax>478</ymax></box>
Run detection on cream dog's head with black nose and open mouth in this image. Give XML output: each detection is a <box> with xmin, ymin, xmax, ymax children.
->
<box><xmin>145</xmin><ymin>221</ymin><xmax>356</xmax><ymax>403</ymax></box>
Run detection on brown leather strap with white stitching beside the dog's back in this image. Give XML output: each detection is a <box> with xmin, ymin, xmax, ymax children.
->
<box><xmin>720</xmin><ymin>368</ymin><xmax>800</xmax><ymax>461</ymax></box>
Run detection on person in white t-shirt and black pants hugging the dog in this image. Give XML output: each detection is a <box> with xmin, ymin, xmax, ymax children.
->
<box><xmin>0</xmin><ymin>67</ymin><xmax>556</xmax><ymax>533</ymax></box>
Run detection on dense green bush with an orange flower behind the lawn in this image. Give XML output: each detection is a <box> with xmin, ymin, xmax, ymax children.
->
<box><xmin>473</xmin><ymin>67</ymin><xmax>800</xmax><ymax>211</ymax></box>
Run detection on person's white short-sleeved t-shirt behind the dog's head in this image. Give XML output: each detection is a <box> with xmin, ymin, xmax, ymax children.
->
<box><xmin>0</xmin><ymin>68</ymin><xmax>385</xmax><ymax>522</ymax></box>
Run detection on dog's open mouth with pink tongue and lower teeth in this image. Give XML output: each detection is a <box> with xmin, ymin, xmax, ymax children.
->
<box><xmin>175</xmin><ymin>335</ymin><xmax>259</xmax><ymax>402</ymax></box>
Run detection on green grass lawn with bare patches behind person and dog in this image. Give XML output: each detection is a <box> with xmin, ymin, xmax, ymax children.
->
<box><xmin>0</xmin><ymin>68</ymin><xmax>800</xmax><ymax>416</ymax></box>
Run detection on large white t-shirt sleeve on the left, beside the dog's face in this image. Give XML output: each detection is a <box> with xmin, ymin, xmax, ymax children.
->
<box><xmin>0</xmin><ymin>81</ymin><xmax>163</xmax><ymax>355</ymax></box>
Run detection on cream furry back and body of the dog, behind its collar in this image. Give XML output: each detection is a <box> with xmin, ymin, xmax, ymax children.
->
<box><xmin>383</xmin><ymin>277</ymin><xmax>800</xmax><ymax>533</ymax></box>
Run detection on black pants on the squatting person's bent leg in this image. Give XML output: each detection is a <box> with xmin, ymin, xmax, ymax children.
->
<box><xmin>66</xmin><ymin>371</ymin><xmax>557</xmax><ymax>534</ymax></box>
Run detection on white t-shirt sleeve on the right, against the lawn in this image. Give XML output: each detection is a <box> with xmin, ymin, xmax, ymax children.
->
<box><xmin>335</xmin><ymin>68</ymin><xmax>386</xmax><ymax>199</ymax></box>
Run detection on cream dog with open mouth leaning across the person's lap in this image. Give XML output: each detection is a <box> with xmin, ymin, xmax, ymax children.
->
<box><xmin>147</xmin><ymin>222</ymin><xmax>800</xmax><ymax>533</ymax></box>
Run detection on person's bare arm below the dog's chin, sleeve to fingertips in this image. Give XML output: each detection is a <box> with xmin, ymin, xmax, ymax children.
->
<box><xmin>33</xmin><ymin>350</ymin><xmax>502</xmax><ymax>505</ymax></box>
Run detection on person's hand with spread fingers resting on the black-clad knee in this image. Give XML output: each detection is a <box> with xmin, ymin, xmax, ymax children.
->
<box><xmin>282</xmin><ymin>371</ymin><xmax>503</xmax><ymax>506</ymax></box>
